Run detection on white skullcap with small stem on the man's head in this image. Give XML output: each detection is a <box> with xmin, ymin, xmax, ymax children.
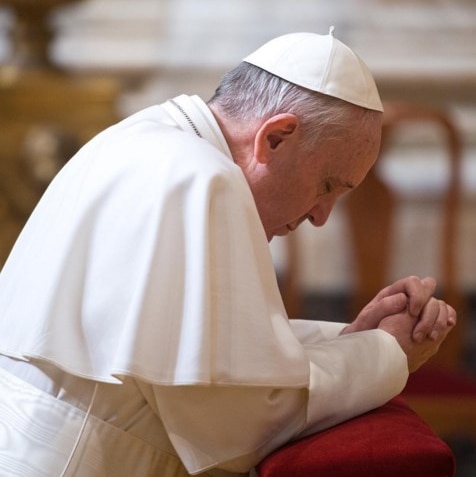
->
<box><xmin>243</xmin><ymin>28</ymin><xmax>383</xmax><ymax>111</ymax></box>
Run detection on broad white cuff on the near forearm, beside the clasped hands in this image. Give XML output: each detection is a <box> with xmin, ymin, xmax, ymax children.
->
<box><xmin>301</xmin><ymin>330</ymin><xmax>408</xmax><ymax>435</ymax></box>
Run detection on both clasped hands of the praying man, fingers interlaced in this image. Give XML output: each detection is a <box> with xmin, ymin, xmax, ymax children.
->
<box><xmin>341</xmin><ymin>276</ymin><xmax>456</xmax><ymax>372</ymax></box>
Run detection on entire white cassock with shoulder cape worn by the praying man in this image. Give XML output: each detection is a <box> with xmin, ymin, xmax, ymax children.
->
<box><xmin>0</xmin><ymin>96</ymin><xmax>408</xmax><ymax>477</ymax></box>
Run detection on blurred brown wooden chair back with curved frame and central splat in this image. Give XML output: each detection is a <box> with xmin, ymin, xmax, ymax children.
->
<box><xmin>344</xmin><ymin>103</ymin><xmax>465</xmax><ymax>367</ymax></box>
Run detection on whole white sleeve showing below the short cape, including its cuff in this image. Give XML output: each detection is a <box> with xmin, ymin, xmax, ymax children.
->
<box><xmin>147</xmin><ymin>322</ymin><xmax>408</xmax><ymax>474</ymax></box>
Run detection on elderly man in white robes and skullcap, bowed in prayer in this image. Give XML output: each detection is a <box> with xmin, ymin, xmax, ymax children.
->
<box><xmin>0</xmin><ymin>29</ymin><xmax>456</xmax><ymax>477</ymax></box>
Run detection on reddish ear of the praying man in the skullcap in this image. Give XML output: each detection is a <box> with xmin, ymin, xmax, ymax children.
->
<box><xmin>254</xmin><ymin>113</ymin><xmax>299</xmax><ymax>164</ymax></box>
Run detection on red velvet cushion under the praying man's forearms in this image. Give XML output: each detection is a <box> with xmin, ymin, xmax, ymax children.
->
<box><xmin>257</xmin><ymin>397</ymin><xmax>455</xmax><ymax>477</ymax></box>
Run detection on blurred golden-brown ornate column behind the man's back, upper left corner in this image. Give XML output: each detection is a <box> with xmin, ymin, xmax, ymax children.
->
<box><xmin>0</xmin><ymin>0</ymin><xmax>120</xmax><ymax>264</ymax></box>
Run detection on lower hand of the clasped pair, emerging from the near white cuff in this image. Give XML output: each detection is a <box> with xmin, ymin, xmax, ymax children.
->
<box><xmin>378</xmin><ymin>298</ymin><xmax>456</xmax><ymax>372</ymax></box>
